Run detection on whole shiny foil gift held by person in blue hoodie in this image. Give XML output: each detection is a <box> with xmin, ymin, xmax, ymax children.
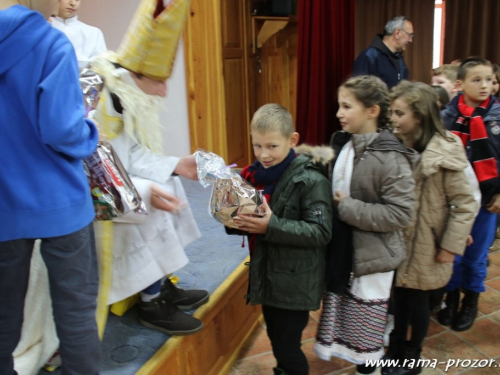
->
<box><xmin>80</xmin><ymin>69</ymin><xmax>147</xmax><ymax>220</ymax></box>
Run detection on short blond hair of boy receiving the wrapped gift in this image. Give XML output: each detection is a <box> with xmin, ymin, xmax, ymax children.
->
<box><xmin>250</xmin><ymin>103</ymin><xmax>295</xmax><ymax>137</ymax></box>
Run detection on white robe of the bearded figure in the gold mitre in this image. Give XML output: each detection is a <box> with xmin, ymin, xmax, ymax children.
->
<box><xmin>98</xmin><ymin>86</ymin><xmax>201</xmax><ymax>304</ymax></box>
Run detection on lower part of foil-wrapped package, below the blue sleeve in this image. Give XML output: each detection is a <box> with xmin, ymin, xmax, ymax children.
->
<box><xmin>84</xmin><ymin>141</ymin><xmax>147</xmax><ymax>220</ymax></box>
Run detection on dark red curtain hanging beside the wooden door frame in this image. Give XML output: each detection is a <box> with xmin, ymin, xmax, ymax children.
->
<box><xmin>296</xmin><ymin>0</ymin><xmax>355</xmax><ymax>145</ymax></box>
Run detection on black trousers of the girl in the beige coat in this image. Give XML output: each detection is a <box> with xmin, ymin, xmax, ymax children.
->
<box><xmin>391</xmin><ymin>287</ymin><xmax>431</xmax><ymax>348</ymax></box>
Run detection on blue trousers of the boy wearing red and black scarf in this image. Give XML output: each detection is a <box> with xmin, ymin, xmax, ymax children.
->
<box><xmin>446</xmin><ymin>208</ymin><xmax>498</xmax><ymax>293</ymax></box>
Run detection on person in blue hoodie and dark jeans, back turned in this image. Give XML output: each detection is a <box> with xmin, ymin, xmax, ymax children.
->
<box><xmin>0</xmin><ymin>0</ymin><xmax>100</xmax><ymax>375</ymax></box>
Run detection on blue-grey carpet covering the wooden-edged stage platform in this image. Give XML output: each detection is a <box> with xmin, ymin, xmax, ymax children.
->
<box><xmin>39</xmin><ymin>179</ymin><xmax>248</xmax><ymax>375</ymax></box>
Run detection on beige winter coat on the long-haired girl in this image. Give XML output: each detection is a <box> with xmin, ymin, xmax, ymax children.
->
<box><xmin>396</xmin><ymin>132</ymin><xmax>478</xmax><ymax>290</ymax></box>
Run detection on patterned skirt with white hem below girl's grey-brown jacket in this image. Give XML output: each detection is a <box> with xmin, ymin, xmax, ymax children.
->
<box><xmin>314</xmin><ymin>271</ymin><xmax>394</xmax><ymax>364</ymax></box>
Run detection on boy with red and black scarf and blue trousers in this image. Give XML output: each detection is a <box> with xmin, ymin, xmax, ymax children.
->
<box><xmin>438</xmin><ymin>57</ymin><xmax>500</xmax><ymax>331</ymax></box>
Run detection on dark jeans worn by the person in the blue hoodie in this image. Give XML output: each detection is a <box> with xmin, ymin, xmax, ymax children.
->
<box><xmin>0</xmin><ymin>223</ymin><xmax>100</xmax><ymax>375</ymax></box>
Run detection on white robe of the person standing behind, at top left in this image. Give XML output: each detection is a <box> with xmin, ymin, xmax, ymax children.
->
<box><xmin>52</xmin><ymin>16</ymin><xmax>106</xmax><ymax>69</ymax></box>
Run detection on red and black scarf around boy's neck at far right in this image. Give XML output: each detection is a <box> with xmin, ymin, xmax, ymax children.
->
<box><xmin>451</xmin><ymin>94</ymin><xmax>499</xmax><ymax>204</ymax></box>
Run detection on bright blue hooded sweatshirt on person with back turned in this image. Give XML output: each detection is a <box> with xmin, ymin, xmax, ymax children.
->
<box><xmin>0</xmin><ymin>5</ymin><xmax>98</xmax><ymax>241</ymax></box>
